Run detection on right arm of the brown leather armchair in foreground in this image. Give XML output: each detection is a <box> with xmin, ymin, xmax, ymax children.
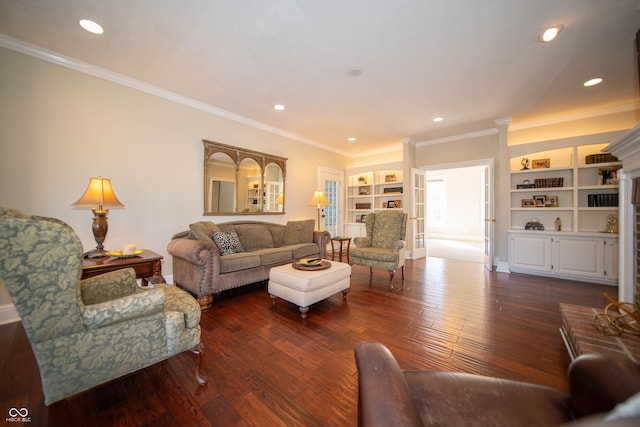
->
<box><xmin>569</xmin><ymin>353</ymin><xmax>640</xmax><ymax>418</ymax></box>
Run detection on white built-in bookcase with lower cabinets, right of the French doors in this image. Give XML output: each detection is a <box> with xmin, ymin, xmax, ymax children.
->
<box><xmin>509</xmin><ymin>144</ymin><xmax>622</xmax><ymax>284</ymax></box>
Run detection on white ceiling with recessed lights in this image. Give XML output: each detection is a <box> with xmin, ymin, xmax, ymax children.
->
<box><xmin>0</xmin><ymin>0</ymin><xmax>640</xmax><ymax>157</ymax></box>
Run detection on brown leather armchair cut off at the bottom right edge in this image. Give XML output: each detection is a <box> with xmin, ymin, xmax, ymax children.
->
<box><xmin>355</xmin><ymin>342</ymin><xmax>640</xmax><ymax>427</ymax></box>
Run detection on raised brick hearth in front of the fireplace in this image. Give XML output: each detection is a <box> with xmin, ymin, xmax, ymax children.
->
<box><xmin>560</xmin><ymin>304</ymin><xmax>640</xmax><ymax>362</ymax></box>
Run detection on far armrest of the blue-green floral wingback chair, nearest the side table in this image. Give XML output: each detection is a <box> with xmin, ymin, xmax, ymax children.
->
<box><xmin>80</xmin><ymin>268</ymin><xmax>138</xmax><ymax>305</ymax></box>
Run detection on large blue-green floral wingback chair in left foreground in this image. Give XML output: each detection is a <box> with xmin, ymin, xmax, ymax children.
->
<box><xmin>0</xmin><ymin>208</ymin><xmax>206</xmax><ymax>405</ymax></box>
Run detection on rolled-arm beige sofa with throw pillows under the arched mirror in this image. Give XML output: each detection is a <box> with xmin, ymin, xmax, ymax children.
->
<box><xmin>167</xmin><ymin>219</ymin><xmax>331</xmax><ymax>308</ymax></box>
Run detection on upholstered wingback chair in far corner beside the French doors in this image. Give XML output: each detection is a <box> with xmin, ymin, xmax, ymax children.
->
<box><xmin>349</xmin><ymin>210</ymin><xmax>407</xmax><ymax>289</ymax></box>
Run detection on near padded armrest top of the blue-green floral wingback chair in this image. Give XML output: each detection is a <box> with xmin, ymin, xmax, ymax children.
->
<box><xmin>82</xmin><ymin>289</ymin><xmax>164</xmax><ymax>329</ymax></box>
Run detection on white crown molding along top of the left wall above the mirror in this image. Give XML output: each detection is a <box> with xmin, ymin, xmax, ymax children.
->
<box><xmin>0</xmin><ymin>34</ymin><xmax>353</xmax><ymax>157</ymax></box>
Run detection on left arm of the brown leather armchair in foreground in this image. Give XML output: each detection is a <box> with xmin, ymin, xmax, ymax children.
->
<box><xmin>355</xmin><ymin>341</ymin><xmax>422</xmax><ymax>427</ymax></box>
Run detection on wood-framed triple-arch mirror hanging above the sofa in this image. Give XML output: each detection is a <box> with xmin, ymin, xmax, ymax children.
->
<box><xmin>202</xmin><ymin>140</ymin><xmax>287</xmax><ymax>215</ymax></box>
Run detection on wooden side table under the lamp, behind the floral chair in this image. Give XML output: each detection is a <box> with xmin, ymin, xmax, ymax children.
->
<box><xmin>81</xmin><ymin>249</ymin><xmax>165</xmax><ymax>286</ymax></box>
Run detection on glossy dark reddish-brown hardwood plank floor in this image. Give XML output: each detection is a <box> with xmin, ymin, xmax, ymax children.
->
<box><xmin>0</xmin><ymin>258</ymin><xmax>617</xmax><ymax>426</ymax></box>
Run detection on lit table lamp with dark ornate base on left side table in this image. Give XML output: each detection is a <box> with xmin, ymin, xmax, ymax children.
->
<box><xmin>72</xmin><ymin>176</ymin><xmax>124</xmax><ymax>258</ymax></box>
